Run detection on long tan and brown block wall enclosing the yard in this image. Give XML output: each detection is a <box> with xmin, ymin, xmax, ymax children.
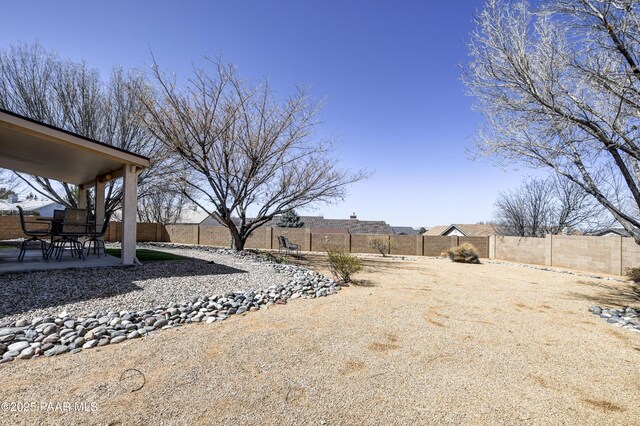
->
<box><xmin>0</xmin><ymin>216</ymin><xmax>640</xmax><ymax>275</ymax></box>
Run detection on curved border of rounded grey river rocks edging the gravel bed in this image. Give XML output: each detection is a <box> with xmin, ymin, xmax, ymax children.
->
<box><xmin>0</xmin><ymin>248</ymin><xmax>340</xmax><ymax>364</ymax></box>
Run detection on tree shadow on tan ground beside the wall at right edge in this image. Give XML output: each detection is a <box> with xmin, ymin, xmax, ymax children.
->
<box><xmin>566</xmin><ymin>281</ymin><xmax>640</xmax><ymax>307</ymax></box>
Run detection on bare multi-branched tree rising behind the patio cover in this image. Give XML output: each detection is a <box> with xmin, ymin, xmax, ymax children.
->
<box><xmin>0</xmin><ymin>44</ymin><xmax>173</xmax><ymax>212</ymax></box>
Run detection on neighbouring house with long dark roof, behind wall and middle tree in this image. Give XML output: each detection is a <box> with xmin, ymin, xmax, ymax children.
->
<box><xmin>200</xmin><ymin>214</ymin><xmax>393</xmax><ymax>235</ymax></box>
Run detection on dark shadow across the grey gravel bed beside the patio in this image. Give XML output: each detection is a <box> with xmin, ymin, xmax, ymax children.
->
<box><xmin>0</xmin><ymin>259</ymin><xmax>247</xmax><ymax>322</ymax></box>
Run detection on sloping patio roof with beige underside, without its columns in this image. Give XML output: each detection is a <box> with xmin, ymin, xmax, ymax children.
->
<box><xmin>0</xmin><ymin>109</ymin><xmax>149</xmax><ymax>187</ymax></box>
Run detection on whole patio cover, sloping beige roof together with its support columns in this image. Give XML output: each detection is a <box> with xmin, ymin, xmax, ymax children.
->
<box><xmin>0</xmin><ymin>109</ymin><xmax>149</xmax><ymax>265</ymax></box>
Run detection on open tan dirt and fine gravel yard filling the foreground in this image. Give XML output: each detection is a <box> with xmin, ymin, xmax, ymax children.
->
<box><xmin>0</xmin><ymin>257</ymin><xmax>640</xmax><ymax>425</ymax></box>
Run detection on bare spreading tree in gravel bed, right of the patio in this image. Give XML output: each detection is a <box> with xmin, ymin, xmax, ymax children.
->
<box><xmin>143</xmin><ymin>60</ymin><xmax>364</xmax><ymax>250</ymax></box>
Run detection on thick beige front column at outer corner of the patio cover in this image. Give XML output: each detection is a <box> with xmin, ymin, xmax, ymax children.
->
<box><xmin>120</xmin><ymin>164</ymin><xmax>138</xmax><ymax>265</ymax></box>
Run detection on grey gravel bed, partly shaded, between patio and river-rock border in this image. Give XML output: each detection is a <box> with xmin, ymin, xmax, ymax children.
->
<box><xmin>0</xmin><ymin>247</ymin><xmax>286</xmax><ymax>324</ymax></box>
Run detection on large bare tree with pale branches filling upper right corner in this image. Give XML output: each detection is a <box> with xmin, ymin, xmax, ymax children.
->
<box><xmin>463</xmin><ymin>0</ymin><xmax>640</xmax><ymax>243</ymax></box>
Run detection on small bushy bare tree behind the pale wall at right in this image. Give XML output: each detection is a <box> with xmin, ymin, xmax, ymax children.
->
<box><xmin>494</xmin><ymin>177</ymin><xmax>613</xmax><ymax>237</ymax></box>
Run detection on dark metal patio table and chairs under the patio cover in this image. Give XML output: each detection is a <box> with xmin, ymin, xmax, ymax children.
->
<box><xmin>18</xmin><ymin>206</ymin><xmax>111</xmax><ymax>261</ymax></box>
